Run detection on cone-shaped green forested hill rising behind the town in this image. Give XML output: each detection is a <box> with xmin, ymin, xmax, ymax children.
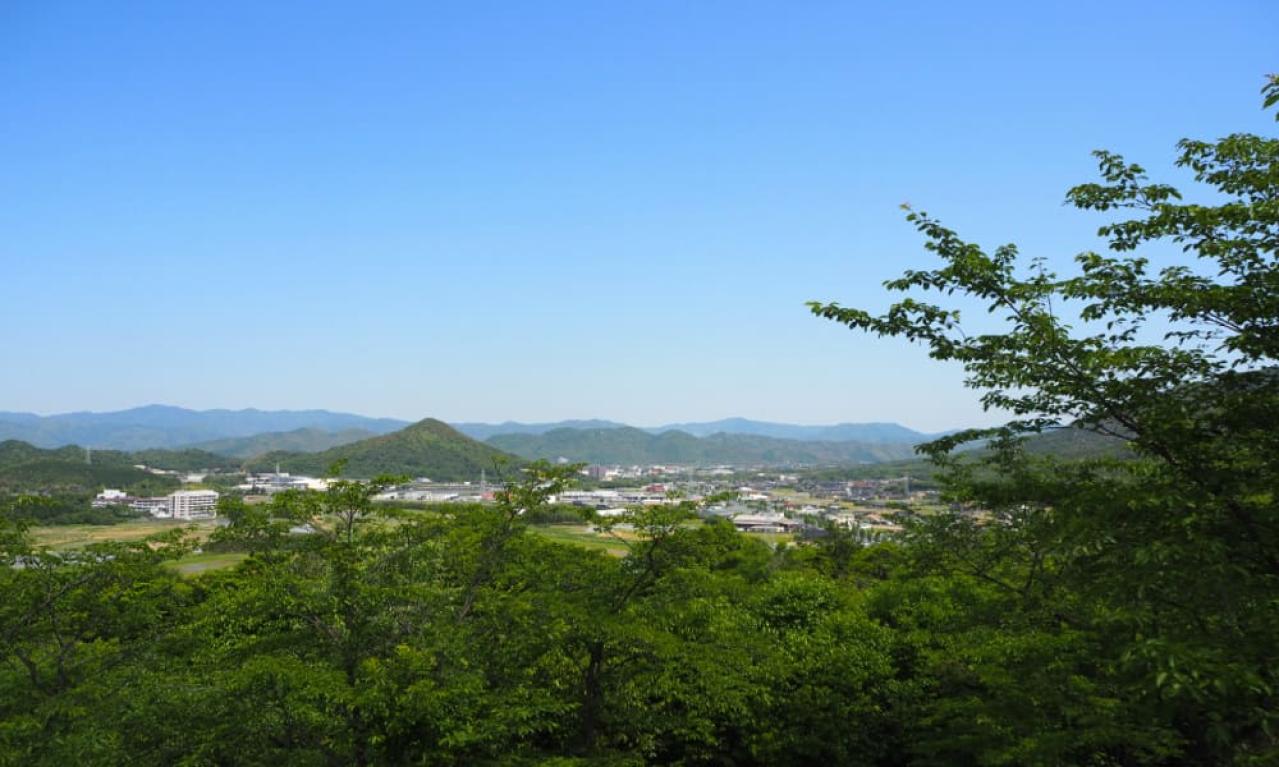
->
<box><xmin>246</xmin><ymin>418</ymin><xmax>521</xmax><ymax>482</ymax></box>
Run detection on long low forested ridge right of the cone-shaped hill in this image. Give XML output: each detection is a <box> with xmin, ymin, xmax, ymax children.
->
<box><xmin>487</xmin><ymin>427</ymin><xmax>913</xmax><ymax>465</ymax></box>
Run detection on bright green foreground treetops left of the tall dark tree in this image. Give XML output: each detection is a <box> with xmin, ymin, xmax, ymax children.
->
<box><xmin>0</xmin><ymin>467</ymin><xmax>899</xmax><ymax>764</ymax></box>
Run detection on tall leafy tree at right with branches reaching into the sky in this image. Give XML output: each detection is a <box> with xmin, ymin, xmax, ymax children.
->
<box><xmin>811</xmin><ymin>77</ymin><xmax>1279</xmax><ymax>763</ymax></box>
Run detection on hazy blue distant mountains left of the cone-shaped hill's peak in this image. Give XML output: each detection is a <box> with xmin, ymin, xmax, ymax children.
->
<box><xmin>0</xmin><ymin>405</ymin><xmax>408</xmax><ymax>450</ymax></box>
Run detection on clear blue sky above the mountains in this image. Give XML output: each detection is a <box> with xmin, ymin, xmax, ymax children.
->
<box><xmin>0</xmin><ymin>0</ymin><xmax>1279</xmax><ymax>430</ymax></box>
